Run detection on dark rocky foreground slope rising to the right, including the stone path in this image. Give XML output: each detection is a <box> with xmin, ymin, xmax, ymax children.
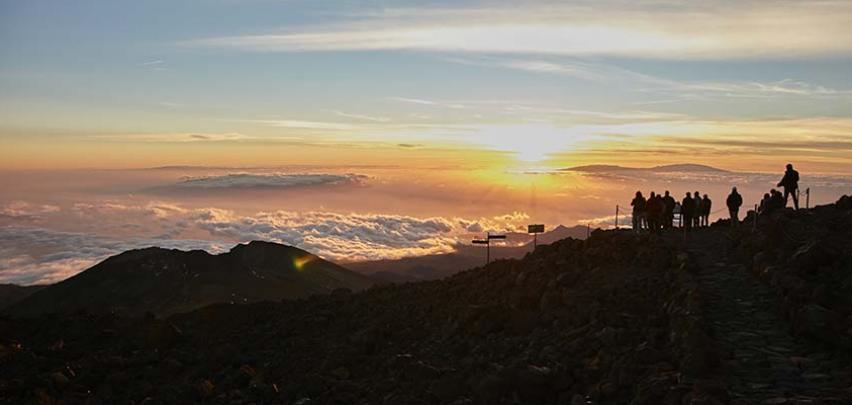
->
<box><xmin>0</xmin><ymin>196</ymin><xmax>852</xmax><ymax>405</ymax></box>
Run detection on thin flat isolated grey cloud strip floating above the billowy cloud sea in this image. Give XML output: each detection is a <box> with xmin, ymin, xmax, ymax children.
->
<box><xmin>171</xmin><ymin>173</ymin><xmax>367</xmax><ymax>189</ymax></box>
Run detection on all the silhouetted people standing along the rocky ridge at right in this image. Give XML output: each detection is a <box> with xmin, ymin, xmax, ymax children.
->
<box><xmin>630</xmin><ymin>164</ymin><xmax>799</xmax><ymax>233</ymax></box>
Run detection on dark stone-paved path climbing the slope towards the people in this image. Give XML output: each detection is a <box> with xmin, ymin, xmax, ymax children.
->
<box><xmin>685</xmin><ymin>228</ymin><xmax>852</xmax><ymax>404</ymax></box>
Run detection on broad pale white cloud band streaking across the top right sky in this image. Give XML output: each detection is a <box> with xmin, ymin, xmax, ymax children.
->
<box><xmin>183</xmin><ymin>0</ymin><xmax>852</xmax><ymax>59</ymax></box>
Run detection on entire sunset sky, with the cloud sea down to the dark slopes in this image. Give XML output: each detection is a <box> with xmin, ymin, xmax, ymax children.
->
<box><xmin>0</xmin><ymin>0</ymin><xmax>852</xmax><ymax>283</ymax></box>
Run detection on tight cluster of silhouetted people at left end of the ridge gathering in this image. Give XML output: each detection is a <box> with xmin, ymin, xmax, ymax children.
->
<box><xmin>630</xmin><ymin>190</ymin><xmax>713</xmax><ymax>233</ymax></box>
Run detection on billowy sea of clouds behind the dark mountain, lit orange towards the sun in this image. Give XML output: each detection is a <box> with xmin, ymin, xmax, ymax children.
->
<box><xmin>0</xmin><ymin>202</ymin><xmax>528</xmax><ymax>284</ymax></box>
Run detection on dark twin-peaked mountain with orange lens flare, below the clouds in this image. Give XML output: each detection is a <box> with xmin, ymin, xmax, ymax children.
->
<box><xmin>6</xmin><ymin>241</ymin><xmax>372</xmax><ymax>316</ymax></box>
